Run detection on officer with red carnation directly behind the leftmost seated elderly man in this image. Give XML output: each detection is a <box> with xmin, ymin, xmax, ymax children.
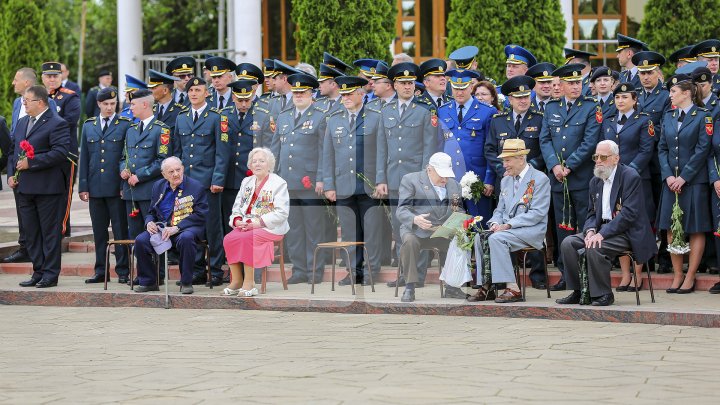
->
<box><xmin>121</xmin><ymin>89</ymin><xmax>170</xmax><ymax>239</ymax></box>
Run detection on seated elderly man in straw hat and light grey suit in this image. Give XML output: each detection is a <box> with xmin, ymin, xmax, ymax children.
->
<box><xmin>476</xmin><ymin>139</ymin><xmax>550</xmax><ymax>303</ymax></box>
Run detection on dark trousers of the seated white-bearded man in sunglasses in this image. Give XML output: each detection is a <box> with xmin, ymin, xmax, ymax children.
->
<box><xmin>560</xmin><ymin>233</ymin><xmax>630</xmax><ymax>297</ymax></box>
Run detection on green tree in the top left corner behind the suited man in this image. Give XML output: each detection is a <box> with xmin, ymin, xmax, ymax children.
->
<box><xmin>0</xmin><ymin>0</ymin><xmax>58</xmax><ymax>119</ymax></box>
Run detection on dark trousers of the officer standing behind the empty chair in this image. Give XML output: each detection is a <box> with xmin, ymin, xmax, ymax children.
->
<box><xmin>337</xmin><ymin>193</ymin><xmax>385</xmax><ymax>277</ymax></box>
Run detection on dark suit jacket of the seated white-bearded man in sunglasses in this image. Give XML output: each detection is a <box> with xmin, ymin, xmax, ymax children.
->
<box><xmin>583</xmin><ymin>165</ymin><xmax>657</xmax><ymax>262</ymax></box>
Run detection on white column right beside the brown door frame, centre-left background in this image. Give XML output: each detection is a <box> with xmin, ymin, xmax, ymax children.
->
<box><xmin>228</xmin><ymin>0</ymin><xmax>262</xmax><ymax>67</ymax></box>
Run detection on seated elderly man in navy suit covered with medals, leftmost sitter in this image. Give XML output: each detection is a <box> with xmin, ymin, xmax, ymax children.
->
<box><xmin>135</xmin><ymin>156</ymin><xmax>208</xmax><ymax>294</ymax></box>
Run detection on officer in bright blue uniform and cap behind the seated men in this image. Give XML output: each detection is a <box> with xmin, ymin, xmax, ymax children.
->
<box><xmin>438</xmin><ymin>69</ymin><xmax>498</xmax><ymax>224</ymax></box>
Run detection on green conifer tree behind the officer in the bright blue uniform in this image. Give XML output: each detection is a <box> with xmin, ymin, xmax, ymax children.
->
<box><xmin>446</xmin><ymin>0</ymin><xmax>565</xmax><ymax>83</ymax></box>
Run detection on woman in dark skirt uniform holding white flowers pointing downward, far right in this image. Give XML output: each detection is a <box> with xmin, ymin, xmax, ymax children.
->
<box><xmin>657</xmin><ymin>74</ymin><xmax>713</xmax><ymax>294</ymax></box>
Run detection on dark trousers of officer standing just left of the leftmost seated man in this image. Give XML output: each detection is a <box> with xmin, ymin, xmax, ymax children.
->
<box><xmin>90</xmin><ymin>196</ymin><xmax>130</xmax><ymax>276</ymax></box>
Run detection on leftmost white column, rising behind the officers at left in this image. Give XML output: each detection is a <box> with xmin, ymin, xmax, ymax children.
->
<box><xmin>117</xmin><ymin>0</ymin><xmax>143</xmax><ymax>102</ymax></box>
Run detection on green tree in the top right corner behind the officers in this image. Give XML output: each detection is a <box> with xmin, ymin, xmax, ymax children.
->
<box><xmin>638</xmin><ymin>0</ymin><xmax>720</xmax><ymax>74</ymax></box>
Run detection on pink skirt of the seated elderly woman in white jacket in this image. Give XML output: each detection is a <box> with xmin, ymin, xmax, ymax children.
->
<box><xmin>223</xmin><ymin>228</ymin><xmax>283</xmax><ymax>268</ymax></box>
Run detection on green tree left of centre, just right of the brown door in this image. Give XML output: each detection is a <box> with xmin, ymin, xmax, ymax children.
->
<box><xmin>290</xmin><ymin>0</ymin><xmax>396</xmax><ymax>66</ymax></box>
